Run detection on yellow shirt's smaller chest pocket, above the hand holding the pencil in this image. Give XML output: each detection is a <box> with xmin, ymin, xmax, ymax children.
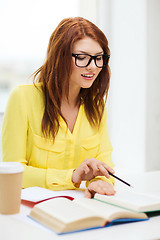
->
<box><xmin>81</xmin><ymin>134</ymin><xmax>100</xmax><ymax>160</ymax></box>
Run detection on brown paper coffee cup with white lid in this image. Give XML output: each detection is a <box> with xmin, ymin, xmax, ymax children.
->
<box><xmin>0</xmin><ymin>162</ymin><xmax>24</xmax><ymax>214</ymax></box>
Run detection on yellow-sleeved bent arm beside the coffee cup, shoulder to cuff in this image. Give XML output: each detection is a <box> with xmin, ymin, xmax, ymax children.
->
<box><xmin>2</xmin><ymin>87</ymin><xmax>78</xmax><ymax>190</ymax></box>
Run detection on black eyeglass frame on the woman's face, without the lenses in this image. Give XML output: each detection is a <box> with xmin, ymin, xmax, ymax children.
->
<box><xmin>72</xmin><ymin>53</ymin><xmax>110</xmax><ymax>68</ymax></box>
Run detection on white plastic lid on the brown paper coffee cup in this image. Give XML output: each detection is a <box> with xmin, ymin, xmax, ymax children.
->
<box><xmin>0</xmin><ymin>162</ymin><xmax>24</xmax><ymax>174</ymax></box>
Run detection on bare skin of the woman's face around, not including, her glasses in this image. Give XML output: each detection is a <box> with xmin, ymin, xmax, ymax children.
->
<box><xmin>69</xmin><ymin>37</ymin><xmax>104</xmax><ymax>92</ymax></box>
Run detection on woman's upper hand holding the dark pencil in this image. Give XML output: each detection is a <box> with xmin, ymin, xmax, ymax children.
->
<box><xmin>72</xmin><ymin>158</ymin><xmax>114</xmax><ymax>183</ymax></box>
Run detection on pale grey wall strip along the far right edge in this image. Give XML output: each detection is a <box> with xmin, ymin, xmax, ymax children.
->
<box><xmin>146</xmin><ymin>0</ymin><xmax>160</xmax><ymax>170</ymax></box>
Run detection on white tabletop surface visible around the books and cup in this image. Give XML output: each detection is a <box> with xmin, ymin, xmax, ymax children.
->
<box><xmin>0</xmin><ymin>171</ymin><xmax>160</xmax><ymax>240</ymax></box>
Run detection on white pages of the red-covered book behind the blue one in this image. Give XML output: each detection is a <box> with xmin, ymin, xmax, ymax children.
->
<box><xmin>21</xmin><ymin>187</ymin><xmax>84</xmax><ymax>203</ymax></box>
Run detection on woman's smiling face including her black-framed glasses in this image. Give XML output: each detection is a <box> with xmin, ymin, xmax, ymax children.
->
<box><xmin>69</xmin><ymin>37</ymin><xmax>103</xmax><ymax>91</ymax></box>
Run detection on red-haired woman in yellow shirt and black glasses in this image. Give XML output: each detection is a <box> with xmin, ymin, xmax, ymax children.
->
<box><xmin>2</xmin><ymin>17</ymin><xmax>115</xmax><ymax>198</ymax></box>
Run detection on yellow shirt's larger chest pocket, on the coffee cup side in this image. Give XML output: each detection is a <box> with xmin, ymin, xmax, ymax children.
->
<box><xmin>29</xmin><ymin>134</ymin><xmax>65</xmax><ymax>169</ymax></box>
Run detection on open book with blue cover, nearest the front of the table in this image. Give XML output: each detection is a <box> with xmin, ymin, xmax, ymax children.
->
<box><xmin>29</xmin><ymin>198</ymin><xmax>148</xmax><ymax>233</ymax></box>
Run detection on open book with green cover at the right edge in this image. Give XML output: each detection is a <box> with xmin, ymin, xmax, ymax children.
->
<box><xmin>94</xmin><ymin>190</ymin><xmax>160</xmax><ymax>212</ymax></box>
